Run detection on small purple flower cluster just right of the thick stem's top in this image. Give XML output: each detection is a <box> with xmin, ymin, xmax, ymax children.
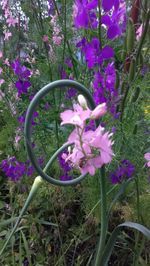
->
<box><xmin>110</xmin><ymin>160</ymin><xmax>135</xmax><ymax>184</ymax></box>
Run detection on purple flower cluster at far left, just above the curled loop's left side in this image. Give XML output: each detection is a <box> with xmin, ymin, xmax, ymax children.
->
<box><xmin>11</xmin><ymin>59</ymin><xmax>31</xmax><ymax>97</ymax></box>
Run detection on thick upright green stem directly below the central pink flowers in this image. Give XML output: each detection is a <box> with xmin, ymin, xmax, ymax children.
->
<box><xmin>94</xmin><ymin>166</ymin><xmax>108</xmax><ymax>266</ymax></box>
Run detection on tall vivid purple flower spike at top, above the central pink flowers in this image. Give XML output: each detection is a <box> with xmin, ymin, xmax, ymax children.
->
<box><xmin>73</xmin><ymin>0</ymin><xmax>126</xmax><ymax>118</ymax></box>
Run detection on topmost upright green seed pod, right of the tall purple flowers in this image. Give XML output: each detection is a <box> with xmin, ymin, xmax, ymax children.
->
<box><xmin>127</xmin><ymin>18</ymin><xmax>135</xmax><ymax>54</ymax></box>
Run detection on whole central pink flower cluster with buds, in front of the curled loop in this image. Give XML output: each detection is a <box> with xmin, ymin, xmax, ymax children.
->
<box><xmin>61</xmin><ymin>95</ymin><xmax>113</xmax><ymax>175</ymax></box>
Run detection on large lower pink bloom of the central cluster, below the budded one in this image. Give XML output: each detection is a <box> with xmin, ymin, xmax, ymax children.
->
<box><xmin>65</xmin><ymin>126</ymin><xmax>113</xmax><ymax>175</ymax></box>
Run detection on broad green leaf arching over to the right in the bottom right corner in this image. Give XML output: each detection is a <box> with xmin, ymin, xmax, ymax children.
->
<box><xmin>101</xmin><ymin>222</ymin><xmax>150</xmax><ymax>266</ymax></box>
